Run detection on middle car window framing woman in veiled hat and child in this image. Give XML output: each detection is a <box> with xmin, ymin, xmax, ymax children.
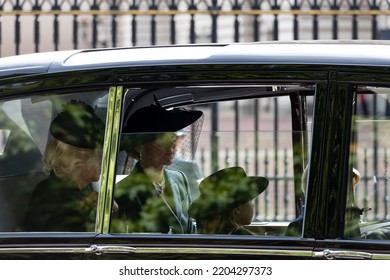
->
<box><xmin>111</xmin><ymin>85</ymin><xmax>316</xmax><ymax>237</ymax></box>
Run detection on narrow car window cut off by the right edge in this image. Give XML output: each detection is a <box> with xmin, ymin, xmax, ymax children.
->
<box><xmin>345</xmin><ymin>86</ymin><xmax>390</xmax><ymax>239</ymax></box>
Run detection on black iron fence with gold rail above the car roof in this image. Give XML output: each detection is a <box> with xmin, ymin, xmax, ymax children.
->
<box><xmin>0</xmin><ymin>0</ymin><xmax>390</xmax><ymax>56</ymax></box>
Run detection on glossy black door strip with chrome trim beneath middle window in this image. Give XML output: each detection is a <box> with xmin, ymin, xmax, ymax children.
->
<box><xmin>88</xmin><ymin>234</ymin><xmax>314</xmax><ymax>259</ymax></box>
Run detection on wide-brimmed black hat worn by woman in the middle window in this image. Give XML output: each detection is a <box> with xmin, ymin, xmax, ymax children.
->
<box><xmin>120</xmin><ymin>105</ymin><xmax>203</xmax><ymax>153</ymax></box>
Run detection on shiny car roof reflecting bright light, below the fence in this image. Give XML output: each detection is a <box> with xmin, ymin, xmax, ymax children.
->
<box><xmin>0</xmin><ymin>40</ymin><xmax>390</xmax><ymax>78</ymax></box>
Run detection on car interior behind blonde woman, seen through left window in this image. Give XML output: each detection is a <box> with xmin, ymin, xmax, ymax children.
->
<box><xmin>0</xmin><ymin>90</ymin><xmax>107</xmax><ymax>232</ymax></box>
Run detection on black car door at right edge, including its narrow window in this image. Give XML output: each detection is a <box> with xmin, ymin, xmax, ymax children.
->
<box><xmin>314</xmin><ymin>71</ymin><xmax>390</xmax><ymax>259</ymax></box>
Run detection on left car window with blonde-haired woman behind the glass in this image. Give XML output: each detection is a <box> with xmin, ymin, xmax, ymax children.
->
<box><xmin>0</xmin><ymin>90</ymin><xmax>108</xmax><ymax>232</ymax></box>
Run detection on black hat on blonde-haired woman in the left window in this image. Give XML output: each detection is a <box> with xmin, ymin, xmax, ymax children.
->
<box><xmin>50</xmin><ymin>100</ymin><xmax>105</xmax><ymax>149</ymax></box>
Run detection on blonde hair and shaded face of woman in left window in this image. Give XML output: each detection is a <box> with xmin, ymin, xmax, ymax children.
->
<box><xmin>43</xmin><ymin>139</ymin><xmax>102</xmax><ymax>181</ymax></box>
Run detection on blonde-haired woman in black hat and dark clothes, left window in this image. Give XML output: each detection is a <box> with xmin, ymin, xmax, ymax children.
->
<box><xmin>26</xmin><ymin>101</ymin><xmax>104</xmax><ymax>231</ymax></box>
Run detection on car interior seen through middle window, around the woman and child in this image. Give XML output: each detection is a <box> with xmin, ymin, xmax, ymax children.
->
<box><xmin>117</xmin><ymin>84</ymin><xmax>315</xmax><ymax>236</ymax></box>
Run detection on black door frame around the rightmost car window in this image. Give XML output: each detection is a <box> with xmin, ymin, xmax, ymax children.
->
<box><xmin>309</xmin><ymin>70</ymin><xmax>390</xmax><ymax>259</ymax></box>
